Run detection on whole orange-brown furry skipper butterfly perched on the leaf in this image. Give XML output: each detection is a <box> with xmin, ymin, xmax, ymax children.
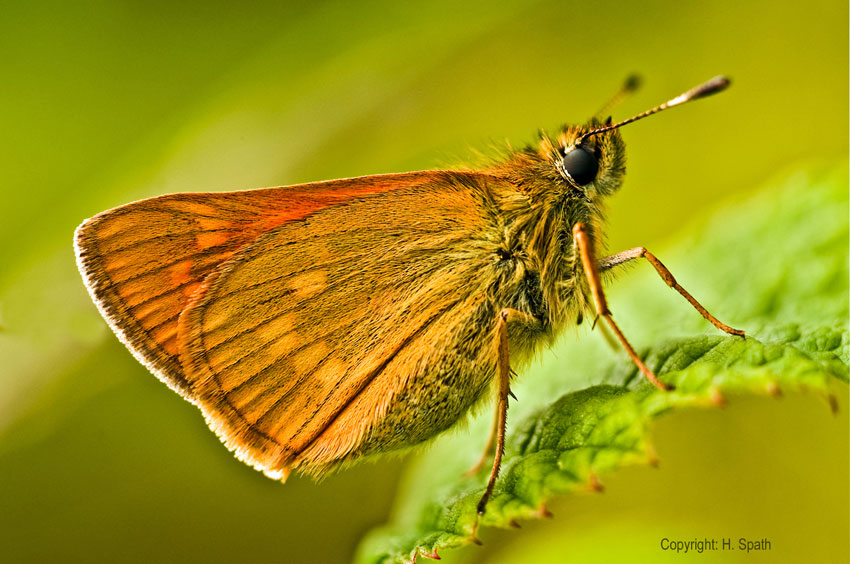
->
<box><xmin>75</xmin><ymin>77</ymin><xmax>743</xmax><ymax>524</ymax></box>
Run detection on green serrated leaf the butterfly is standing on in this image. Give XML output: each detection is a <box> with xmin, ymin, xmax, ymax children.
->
<box><xmin>357</xmin><ymin>163</ymin><xmax>850</xmax><ymax>563</ymax></box>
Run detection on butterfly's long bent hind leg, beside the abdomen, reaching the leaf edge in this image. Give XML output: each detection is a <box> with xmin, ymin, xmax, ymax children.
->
<box><xmin>473</xmin><ymin>308</ymin><xmax>537</xmax><ymax>528</ymax></box>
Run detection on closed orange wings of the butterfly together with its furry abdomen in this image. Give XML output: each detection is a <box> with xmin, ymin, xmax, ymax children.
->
<box><xmin>76</xmin><ymin>171</ymin><xmax>510</xmax><ymax>478</ymax></box>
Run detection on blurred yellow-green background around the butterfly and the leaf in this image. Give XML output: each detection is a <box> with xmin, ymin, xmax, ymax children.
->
<box><xmin>0</xmin><ymin>0</ymin><xmax>848</xmax><ymax>562</ymax></box>
